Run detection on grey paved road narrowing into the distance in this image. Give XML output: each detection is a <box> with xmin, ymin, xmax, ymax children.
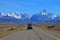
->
<box><xmin>0</xmin><ymin>28</ymin><xmax>60</xmax><ymax>40</ymax></box>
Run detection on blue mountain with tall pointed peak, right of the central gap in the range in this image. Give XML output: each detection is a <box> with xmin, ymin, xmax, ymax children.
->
<box><xmin>30</xmin><ymin>10</ymin><xmax>60</xmax><ymax>23</ymax></box>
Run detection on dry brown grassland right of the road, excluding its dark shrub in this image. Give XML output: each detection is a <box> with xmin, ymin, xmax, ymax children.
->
<box><xmin>34</xmin><ymin>24</ymin><xmax>60</xmax><ymax>35</ymax></box>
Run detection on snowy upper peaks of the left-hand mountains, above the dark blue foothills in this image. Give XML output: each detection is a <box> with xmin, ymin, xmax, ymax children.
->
<box><xmin>0</xmin><ymin>12</ymin><xmax>29</xmax><ymax>19</ymax></box>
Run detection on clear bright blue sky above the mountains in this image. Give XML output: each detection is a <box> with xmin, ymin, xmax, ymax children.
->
<box><xmin>0</xmin><ymin>0</ymin><xmax>60</xmax><ymax>16</ymax></box>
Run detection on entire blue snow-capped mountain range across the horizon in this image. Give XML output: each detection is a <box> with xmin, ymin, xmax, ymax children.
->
<box><xmin>0</xmin><ymin>10</ymin><xmax>60</xmax><ymax>24</ymax></box>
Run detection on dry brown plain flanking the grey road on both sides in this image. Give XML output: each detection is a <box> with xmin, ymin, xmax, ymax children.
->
<box><xmin>0</xmin><ymin>23</ymin><xmax>60</xmax><ymax>38</ymax></box>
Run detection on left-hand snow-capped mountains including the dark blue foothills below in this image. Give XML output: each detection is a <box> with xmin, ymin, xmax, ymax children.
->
<box><xmin>0</xmin><ymin>13</ymin><xmax>29</xmax><ymax>24</ymax></box>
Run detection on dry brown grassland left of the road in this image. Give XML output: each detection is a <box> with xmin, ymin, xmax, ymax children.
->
<box><xmin>0</xmin><ymin>24</ymin><xmax>26</xmax><ymax>38</ymax></box>
